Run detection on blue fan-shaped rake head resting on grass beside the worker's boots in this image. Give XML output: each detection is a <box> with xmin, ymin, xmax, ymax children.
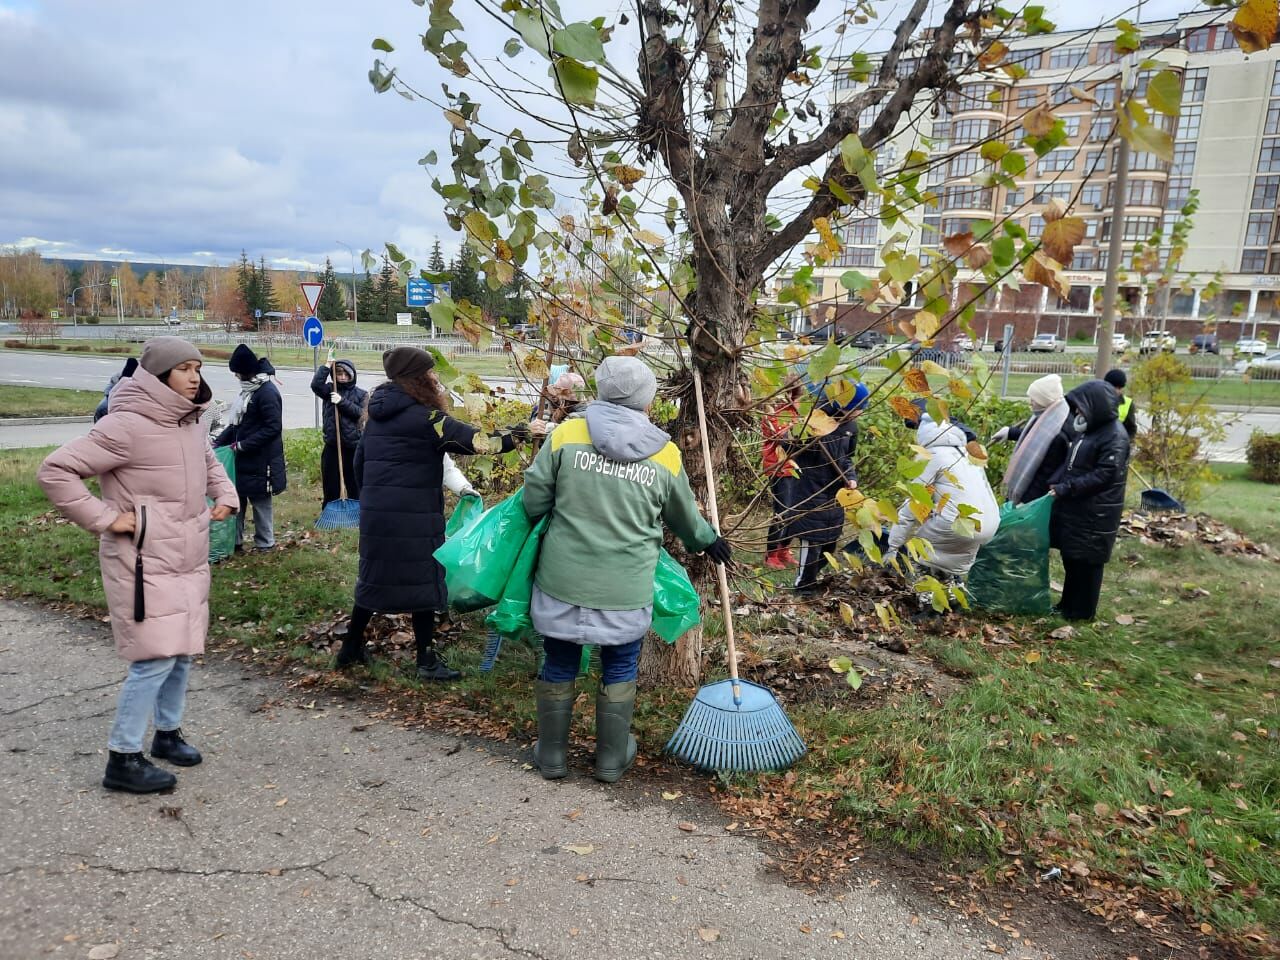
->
<box><xmin>664</xmin><ymin>680</ymin><xmax>808</xmax><ymax>773</ymax></box>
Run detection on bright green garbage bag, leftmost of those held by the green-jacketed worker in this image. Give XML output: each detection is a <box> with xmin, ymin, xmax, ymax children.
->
<box><xmin>435</xmin><ymin>490</ymin><xmax>534</xmax><ymax>612</ymax></box>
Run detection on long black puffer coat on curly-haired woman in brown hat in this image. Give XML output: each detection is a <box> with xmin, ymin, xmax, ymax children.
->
<box><xmin>356</xmin><ymin>383</ymin><xmax>512</xmax><ymax>613</ymax></box>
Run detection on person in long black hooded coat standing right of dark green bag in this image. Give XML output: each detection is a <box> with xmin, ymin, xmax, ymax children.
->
<box><xmin>1050</xmin><ymin>380</ymin><xmax>1129</xmax><ymax>620</ymax></box>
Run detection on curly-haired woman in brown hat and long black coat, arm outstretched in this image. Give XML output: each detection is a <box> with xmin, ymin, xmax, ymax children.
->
<box><xmin>335</xmin><ymin>347</ymin><xmax>529</xmax><ymax>681</ymax></box>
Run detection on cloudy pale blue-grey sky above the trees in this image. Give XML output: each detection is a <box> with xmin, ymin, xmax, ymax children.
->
<box><xmin>0</xmin><ymin>0</ymin><xmax>1194</xmax><ymax>269</ymax></box>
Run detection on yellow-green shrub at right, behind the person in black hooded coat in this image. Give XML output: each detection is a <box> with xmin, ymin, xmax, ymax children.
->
<box><xmin>1132</xmin><ymin>353</ymin><xmax>1226</xmax><ymax>500</ymax></box>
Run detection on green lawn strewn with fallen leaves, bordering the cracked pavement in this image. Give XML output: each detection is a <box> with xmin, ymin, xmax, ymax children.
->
<box><xmin>0</xmin><ymin>440</ymin><xmax>1280</xmax><ymax>948</ymax></box>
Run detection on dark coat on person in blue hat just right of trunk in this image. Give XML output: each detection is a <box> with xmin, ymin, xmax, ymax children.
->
<box><xmin>782</xmin><ymin>408</ymin><xmax>858</xmax><ymax>544</ymax></box>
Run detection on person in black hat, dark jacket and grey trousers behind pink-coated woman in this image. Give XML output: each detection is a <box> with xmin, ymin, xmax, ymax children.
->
<box><xmin>214</xmin><ymin>343</ymin><xmax>288</xmax><ymax>550</ymax></box>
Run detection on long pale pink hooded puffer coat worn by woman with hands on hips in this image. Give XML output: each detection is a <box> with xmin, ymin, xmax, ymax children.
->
<box><xmin>36</xmin><ymin>369</ymin><xmax>239</xmax><ymax>660</ymax></box>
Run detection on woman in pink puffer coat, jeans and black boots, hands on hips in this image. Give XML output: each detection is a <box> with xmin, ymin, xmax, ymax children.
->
<box><xmin>36</xmin><ymin>337</ymin><xmax>239</xmax><ymax>794</ymax></box>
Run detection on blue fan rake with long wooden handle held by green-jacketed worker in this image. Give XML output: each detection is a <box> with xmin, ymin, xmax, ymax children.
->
<box><xmin>666</xmin><ymin>366</ymin><xmax>806</xmax><ymax>772</ymax></box>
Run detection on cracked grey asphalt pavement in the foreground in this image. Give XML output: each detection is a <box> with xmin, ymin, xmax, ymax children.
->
<box><xmin>0</xmin><ymin>603</ymin><xmax>1051</xmax><ymax>960</ymax></box>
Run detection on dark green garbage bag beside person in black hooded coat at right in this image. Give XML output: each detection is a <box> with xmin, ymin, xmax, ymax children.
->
<box><xmin>966</xmin><ymin>497</ymin><xmax>1053</xmax><ymax>614</ymax></box>
